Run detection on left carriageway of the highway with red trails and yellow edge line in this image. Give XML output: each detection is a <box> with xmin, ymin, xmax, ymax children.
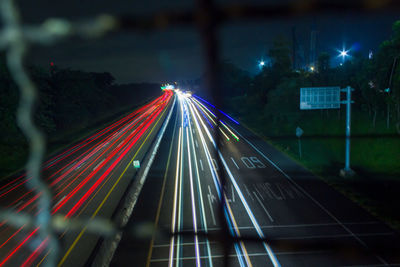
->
<box><xmin>0</xmin><ymin>91</ymin><xmax>174</xmax><ymax>266</ymax></box>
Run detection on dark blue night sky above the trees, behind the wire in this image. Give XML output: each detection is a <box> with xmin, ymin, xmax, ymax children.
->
<box><xmin>19</xmin><ymin>0</ymin><xmax>400</xmax><ymax>83</ymax></box>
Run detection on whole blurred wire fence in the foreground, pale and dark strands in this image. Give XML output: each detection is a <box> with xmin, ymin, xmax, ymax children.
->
<box><xmin>0</xmin><ymin>0</ymin><xmax>400</xmax><ymax>266</ymax></box>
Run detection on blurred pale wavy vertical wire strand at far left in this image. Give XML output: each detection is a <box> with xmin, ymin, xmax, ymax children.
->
<box><xmin>0</xmin><ymin>0</ymin><xmax>59</xmax><ymax>266</ymax></box>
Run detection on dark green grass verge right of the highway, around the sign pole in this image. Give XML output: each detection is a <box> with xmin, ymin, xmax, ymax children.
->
<box><xmin>241</xmin><ymin>113</ymin><xmax>400</xmax><ymax>231</ymax></box>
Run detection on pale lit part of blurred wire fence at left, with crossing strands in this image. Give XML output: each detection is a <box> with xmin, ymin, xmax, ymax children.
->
<box><xmin>0</xmin><ymin>0</ymin><xmax>120</xmax><ymax>266</ymax></box>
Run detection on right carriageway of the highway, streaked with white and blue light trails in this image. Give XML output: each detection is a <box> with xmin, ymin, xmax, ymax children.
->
<box><xmin>111</xmin><ymin>93</ymin><xmax>400</xmax><ymax>266</ymax></box>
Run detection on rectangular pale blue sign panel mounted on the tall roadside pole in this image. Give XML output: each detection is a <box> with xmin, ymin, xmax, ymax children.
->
<box><xmin>300</xmin><ymin>86</ymin><xmax>340</xmax><ymax>110</ymax></box>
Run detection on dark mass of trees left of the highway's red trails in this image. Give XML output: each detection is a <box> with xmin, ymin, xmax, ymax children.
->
<box><xmin>0</xmin><ymin>59</ymin><xmax>160</xmax><ymax>177</ymax></box>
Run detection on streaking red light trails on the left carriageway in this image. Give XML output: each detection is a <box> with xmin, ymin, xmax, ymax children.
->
<box><xmin>0</xmin><ymin>90</ymin><xmax>173</xmax><ymax>266</ymax></box>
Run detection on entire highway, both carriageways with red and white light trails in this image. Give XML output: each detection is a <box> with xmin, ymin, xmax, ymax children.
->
<box><xmin>0</xmin><ymin>90</ymin><xmax>400</xmax><ymax>266</ymax></box>
